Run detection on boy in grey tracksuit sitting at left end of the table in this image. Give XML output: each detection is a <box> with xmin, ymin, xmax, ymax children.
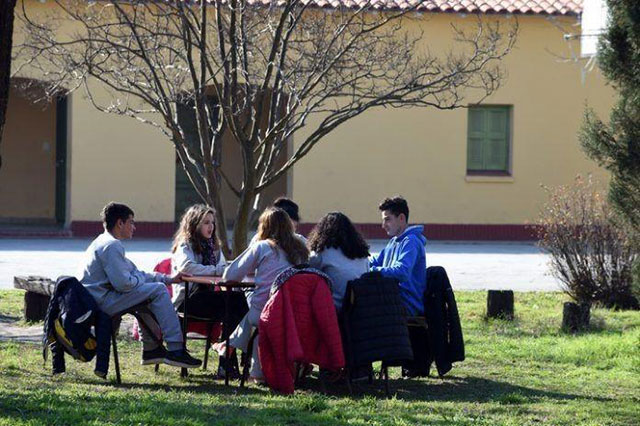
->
<box><xmin>78</xmin><ymin>202</ymin><xmax>201</xmax><ymax>368</ymax></box>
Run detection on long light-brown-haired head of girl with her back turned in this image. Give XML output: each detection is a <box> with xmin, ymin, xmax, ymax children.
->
<box><xmin>258</xmin><ymin>207</ymin><xmax>309</xmax><ymax>265</ymax></box>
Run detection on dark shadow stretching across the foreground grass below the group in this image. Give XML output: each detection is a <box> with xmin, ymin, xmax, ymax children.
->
<box><xmin>0</xmin><ymin>366</ymin><xmax>624</xmax><ymax>425</ymax></box>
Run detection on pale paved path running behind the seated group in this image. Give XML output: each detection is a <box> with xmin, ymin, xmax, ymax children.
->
<box><xmin>0</xmin><ymin>239</ymin><xmax>559</xmax><ymax>291</ymax></box>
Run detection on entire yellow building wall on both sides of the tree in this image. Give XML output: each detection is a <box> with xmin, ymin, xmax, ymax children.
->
<box><xmin>8</xmin><ymin>3</ymin><xmax>614</xmax><ymax>224</ymax></box>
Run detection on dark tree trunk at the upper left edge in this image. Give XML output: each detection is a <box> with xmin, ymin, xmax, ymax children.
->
<box><xmin>0</xmin><ymin>0</ymin><xmax>16</xmax><ymax>168</ymax></box>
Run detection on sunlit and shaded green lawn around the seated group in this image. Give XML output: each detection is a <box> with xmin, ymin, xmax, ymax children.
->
<box><xmin>0</xmin><ymin>291</ymin><xmax>640</xmax><ymax>426</ymax></box>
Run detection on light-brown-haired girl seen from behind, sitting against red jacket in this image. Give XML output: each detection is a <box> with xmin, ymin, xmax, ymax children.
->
<box><xmin>223</xmin><ymin>207</ymin><xmax>309</xmax><ymax>381</ymax></box>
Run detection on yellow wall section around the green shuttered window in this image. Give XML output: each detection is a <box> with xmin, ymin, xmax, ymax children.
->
<box><xmin>292</xmin><ymin>14</ymin><xmax>614</xmax><ymax>224</ymax></box>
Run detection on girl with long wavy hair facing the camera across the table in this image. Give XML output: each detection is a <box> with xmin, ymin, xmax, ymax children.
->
<box><xmin>171</xmin><ymin>204</ymin><xmax>249</xmax><ymax>376</ymax></box>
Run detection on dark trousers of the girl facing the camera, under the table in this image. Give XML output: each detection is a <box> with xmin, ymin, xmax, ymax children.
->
<box><xmin>178</xmin><ymin>289</ymin><xmax>249</xmax><ymax>340</ymax></box>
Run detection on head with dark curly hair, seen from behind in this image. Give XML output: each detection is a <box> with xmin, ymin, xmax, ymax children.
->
<box><xmin>307</xmin><ymin>212</ymin><xmax>369</xmax><ymax>259</ymax></box>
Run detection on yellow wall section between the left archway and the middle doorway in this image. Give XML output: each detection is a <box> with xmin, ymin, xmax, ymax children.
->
<box><xmin>69</xmin><ymin>91</ymin><xmax>175</xmax><ymax>222</ymax></box>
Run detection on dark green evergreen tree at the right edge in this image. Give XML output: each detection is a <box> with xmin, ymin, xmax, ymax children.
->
<box><xmin>580</xmin><ymin>0</ymin><xmax>640</xmax><ymax>299</ymax></box>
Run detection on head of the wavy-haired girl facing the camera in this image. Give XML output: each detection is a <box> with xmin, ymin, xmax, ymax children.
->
<box><xmin>172</xmin><ymin>204</ymin><xmax>217</xmax><ymax>253</ymax></box>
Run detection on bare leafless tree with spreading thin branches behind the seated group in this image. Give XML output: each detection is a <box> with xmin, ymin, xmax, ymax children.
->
<box><xmin>13</xmin><ymin>0</ymin><xmax>517</xmax><ymax>255</ymax></box>
